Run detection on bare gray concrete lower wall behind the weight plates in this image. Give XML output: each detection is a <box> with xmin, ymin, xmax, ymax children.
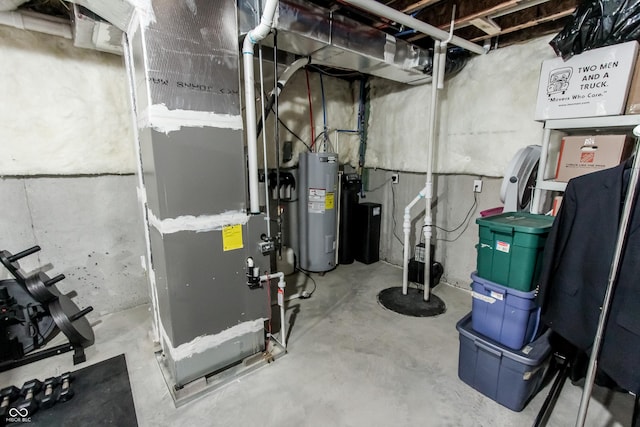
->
<box><xmin>0</xmin><ymin>175</ymin><xmax>149</xmax><ymax>316</ymax></box>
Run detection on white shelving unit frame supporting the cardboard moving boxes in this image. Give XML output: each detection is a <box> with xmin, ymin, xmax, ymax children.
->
<box><xmin>531</xmin><ymin>114</ymin><xmax>640</xmax><ymax>213</ymax></box>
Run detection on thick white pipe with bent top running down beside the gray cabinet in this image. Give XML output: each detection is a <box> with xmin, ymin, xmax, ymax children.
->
<box><xmin>242</xmin><ymin>0</ymin><xmax>278</xmax><ymax>214</ymax></box>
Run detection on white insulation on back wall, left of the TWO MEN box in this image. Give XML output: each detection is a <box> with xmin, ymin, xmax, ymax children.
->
<box><xmin>366</xmin><ymin>36</ymin><xmax>555</xmax><ymax>177</ymax></box>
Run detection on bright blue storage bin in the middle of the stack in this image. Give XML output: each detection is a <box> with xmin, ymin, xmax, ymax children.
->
<box><xmin>471</xmin><ymin>273</ymin><xmax>538</xmax><ymax>350</ymax></box>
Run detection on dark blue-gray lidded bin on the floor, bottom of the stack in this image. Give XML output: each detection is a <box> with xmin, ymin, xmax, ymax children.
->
<box><xmin>456</xmin><ymin>313</ymin><xmax>551</xmax><ymax>412</ymax></box>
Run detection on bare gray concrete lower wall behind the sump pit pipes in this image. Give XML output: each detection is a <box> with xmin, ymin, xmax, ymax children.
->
<box><xmin>361</xmin><ymin>169</ymin><xmax>502</xmax><ymax>289</ymax></box>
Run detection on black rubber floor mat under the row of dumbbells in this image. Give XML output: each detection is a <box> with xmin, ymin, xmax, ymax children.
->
<box><xmin>27</xmin><ymin>354</ymin><xmax>138</xmax><ymax>427</ymax></box>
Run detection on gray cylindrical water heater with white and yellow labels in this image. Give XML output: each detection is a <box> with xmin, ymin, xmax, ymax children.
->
<box><xmin>298</xmin><ymin>152</ymin><xmax>338</xmax><ymax>272</ymax></box>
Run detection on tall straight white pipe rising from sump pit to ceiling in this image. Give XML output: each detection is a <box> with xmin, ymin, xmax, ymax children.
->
<box><xmin>424</xmin><ymin>40</ymin><xmax>442</xmax><ymax>301</ymax></box>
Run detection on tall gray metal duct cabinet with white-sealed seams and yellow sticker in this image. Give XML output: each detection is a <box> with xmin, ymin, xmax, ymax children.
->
<box><xmin>126</xmin><ymin>0</ymin><xmax>269</xmax><ymax>397</ymax></box>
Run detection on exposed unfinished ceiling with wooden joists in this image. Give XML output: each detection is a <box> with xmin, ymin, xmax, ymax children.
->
<box><xmin>15</xmin><ymin>0</ymin><xmax>579</xmax><ymax>48</ymax></box>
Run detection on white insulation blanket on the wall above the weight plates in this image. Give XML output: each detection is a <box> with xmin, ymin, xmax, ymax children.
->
<box><xmin>0</xmin><ymin>27</ymin><xmax>136</xmax><ymax>175</ymax></box>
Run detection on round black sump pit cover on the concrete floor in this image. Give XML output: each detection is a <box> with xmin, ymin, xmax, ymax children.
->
<box><xmin>378</xmin><ymin>287</ymin><xmax>447</xmax><ymax>317</ymax></box>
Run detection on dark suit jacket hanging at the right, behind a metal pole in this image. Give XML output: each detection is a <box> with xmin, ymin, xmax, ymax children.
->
<box><xmin>537</xmin><ymin>163</ymin><xmax>640</xmax><ymax>393</ymax></box>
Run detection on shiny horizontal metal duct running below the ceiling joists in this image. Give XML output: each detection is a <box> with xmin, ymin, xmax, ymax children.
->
<box><xmin>238</xmin><ymin>0</ymin><xmax>431</xmax><ymax>84</ymax></box>
